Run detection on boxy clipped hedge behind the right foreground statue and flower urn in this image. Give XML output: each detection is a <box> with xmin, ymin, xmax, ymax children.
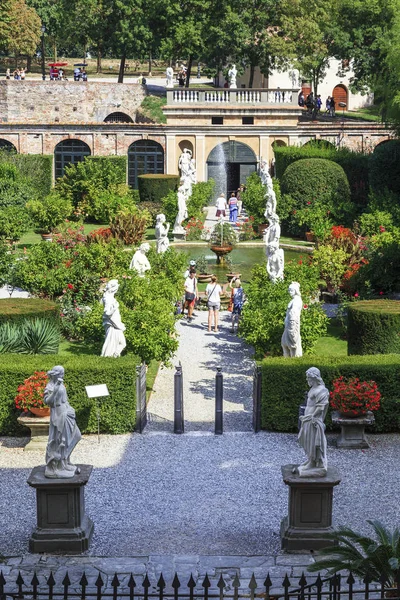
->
<box><xmin>261</xmin><ymin>354</ymin><xmax>400</xmax><ymax>433</ymax></box>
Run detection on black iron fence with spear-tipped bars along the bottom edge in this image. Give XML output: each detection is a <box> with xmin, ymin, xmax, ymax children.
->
<box><xmin>0</xmin><ymin>571</ymin><xmax>400</xmax><ymax>600</ymax></box>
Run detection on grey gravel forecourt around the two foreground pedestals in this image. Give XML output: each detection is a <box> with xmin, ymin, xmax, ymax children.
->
<box><xmin>0</xmin><ymin>432</ymin><xmax>400</xmax><ymax>564</ymax></box>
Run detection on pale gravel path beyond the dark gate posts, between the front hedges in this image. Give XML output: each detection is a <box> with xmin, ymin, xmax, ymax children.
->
<box><xmin>146</xmin><ymin>310</ymin><xmax>253</xmax><ymax>432</ymax></box>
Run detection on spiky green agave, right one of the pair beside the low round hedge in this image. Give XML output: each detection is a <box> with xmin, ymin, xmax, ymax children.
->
<box><xmin>18</xmin><ymin>319</ymin><xmax>60</xmax><ymax>354</ymax></box>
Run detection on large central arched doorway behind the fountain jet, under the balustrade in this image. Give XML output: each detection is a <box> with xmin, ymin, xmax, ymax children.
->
<box><xmin>207</xmin><ymin>141</ymin><xmax>257</xmax><ymax>195</ymax></box>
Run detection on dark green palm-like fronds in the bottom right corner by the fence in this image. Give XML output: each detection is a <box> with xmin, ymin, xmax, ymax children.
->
<box><xmin>308</xmin><ymin>521</ymin><xmax>400</xmax><ymax>587</ymax></box>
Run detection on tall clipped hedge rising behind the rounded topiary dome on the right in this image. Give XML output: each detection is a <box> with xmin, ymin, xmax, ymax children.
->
<box><xmin>274</xmin><ymin>144</ymin><xmax>369</xmax><ymax>212</ymax></box>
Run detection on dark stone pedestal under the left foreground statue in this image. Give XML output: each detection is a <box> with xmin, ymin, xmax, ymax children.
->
<box><xmin>28</xmin><ymin>465</ymin><xmax>93</xmax><ymax>554</ymax></box>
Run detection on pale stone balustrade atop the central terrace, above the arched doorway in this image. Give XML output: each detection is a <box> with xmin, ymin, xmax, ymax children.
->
<box><xmin>167</xmin><ymin>88</ymin><xmax>300</xmax><ymax>107</ymax></box>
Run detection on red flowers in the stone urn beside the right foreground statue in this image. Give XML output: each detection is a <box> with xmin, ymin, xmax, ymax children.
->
<box><xmin>330</xmin><ymin>377</ymin><xmax>381</xmax><ymax>417</ymax></box>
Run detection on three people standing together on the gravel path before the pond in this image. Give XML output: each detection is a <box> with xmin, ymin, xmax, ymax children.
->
<box><xmin>183</xmin><ymin>260</ymin><xmax>245</xmax><ymax>333</ymax></box>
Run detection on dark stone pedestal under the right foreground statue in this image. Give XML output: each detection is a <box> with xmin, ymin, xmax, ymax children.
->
<box><xmin>281</xmin><ymin>465</ymin><xmax>340</xmax><ymax>552</ymax></box>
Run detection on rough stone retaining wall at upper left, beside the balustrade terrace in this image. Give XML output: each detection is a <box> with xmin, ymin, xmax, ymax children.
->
<box><xmin>0</xmin><ymin>80</ymin><xmax>146</xmax><ymax>125</ymax></box>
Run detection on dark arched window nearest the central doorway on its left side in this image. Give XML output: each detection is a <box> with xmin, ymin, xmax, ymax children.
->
<box><xmin>128</xmin><ymin>140</ymin><xmax>164</xmax><ymax>189</ymax></box>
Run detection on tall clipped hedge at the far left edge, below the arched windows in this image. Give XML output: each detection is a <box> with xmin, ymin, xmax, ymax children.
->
<box><xmin>0</xmin><ymin>152</ymin><xmax>53</xmax><ymax>198</ymax></box>
